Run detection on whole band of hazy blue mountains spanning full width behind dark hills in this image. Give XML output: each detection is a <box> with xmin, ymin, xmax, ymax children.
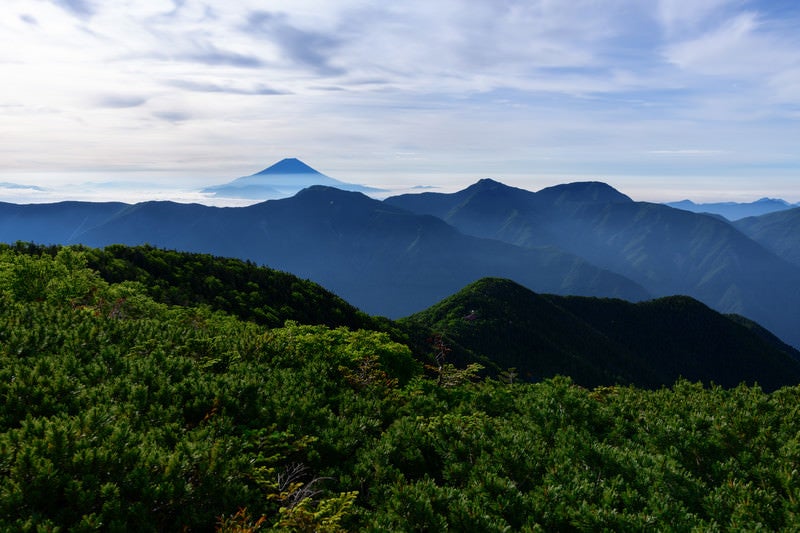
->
<box><xmin>0</xmin><ymin>163</ymin><xmax>800</xmax><ymax>346</ymax></box>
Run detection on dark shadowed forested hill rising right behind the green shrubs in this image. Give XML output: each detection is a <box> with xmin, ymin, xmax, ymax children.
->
<box><xmin>401</xmin><ymin>279</ymin><xmax>800</xmax><ymax>389</ymax></box>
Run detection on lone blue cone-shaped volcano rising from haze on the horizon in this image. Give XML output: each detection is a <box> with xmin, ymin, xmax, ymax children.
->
<box><xmin>201</xmin><ymin>158</ymin><xmax>382</xmax><ymax>200</ymax></box>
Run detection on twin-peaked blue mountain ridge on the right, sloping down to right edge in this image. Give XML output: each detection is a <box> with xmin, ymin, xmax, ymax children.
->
<box><xmin>384</xmin><ymin>182</ymin><xmax>800</xmax><ymax>346</ymax></box>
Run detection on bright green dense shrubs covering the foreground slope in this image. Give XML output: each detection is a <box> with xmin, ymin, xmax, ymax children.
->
<box><xmin>0</xmin><ymin>247</ymin><xmax>800</xmax><ymax>531</ymax></box>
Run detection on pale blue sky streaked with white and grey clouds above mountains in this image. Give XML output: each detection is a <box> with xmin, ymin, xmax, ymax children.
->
<box><xmin>0</xmin><ymin>0</ymin><xmax>800</xmax><ymax>205</ymax></box>
